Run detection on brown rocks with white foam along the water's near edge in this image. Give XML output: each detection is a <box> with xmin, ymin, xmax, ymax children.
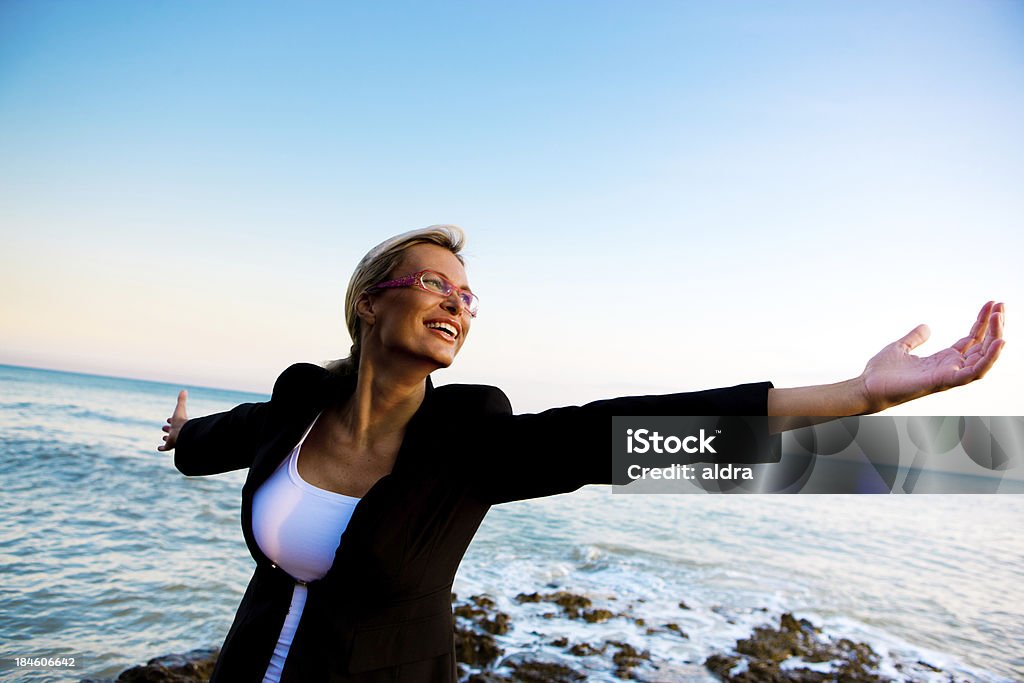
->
<box><xmin>81</xmin><ymin>591</ymin><xmax>956</xmax><ymax>683</ymax></box>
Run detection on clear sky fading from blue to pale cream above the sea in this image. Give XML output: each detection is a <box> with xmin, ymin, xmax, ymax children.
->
<box><xmin>0</xmin><ymin>0</ymin><xmax>1024</xmax><ymax>415</ymax></box>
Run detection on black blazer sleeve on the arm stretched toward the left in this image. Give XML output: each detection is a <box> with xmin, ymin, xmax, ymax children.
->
<box><xmin>174</xmin><ymin>364</ymin><xmax>325</xmax><ymax>476</ymax></box>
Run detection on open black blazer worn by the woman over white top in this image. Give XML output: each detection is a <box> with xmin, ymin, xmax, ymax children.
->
<box><xmin>174</xmin><ymin>364</ymin><xmax>771</xmax><ymax>683</ymax></box>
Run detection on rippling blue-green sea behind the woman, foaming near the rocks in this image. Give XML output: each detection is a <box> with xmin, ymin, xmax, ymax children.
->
<box><xmin>0</xmin><ymin>366</ymin><xmax>1024</xmax><ymax>682</ymax></box>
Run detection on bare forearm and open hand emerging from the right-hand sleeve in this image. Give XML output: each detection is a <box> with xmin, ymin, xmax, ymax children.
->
<box><xmin>768</xmin><ymin>301</ymin><xmax>1006</xmax><ymax>433</ymax></box>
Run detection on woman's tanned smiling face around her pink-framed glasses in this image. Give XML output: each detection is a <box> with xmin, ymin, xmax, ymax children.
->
<box><xmin>357</xmin><ymin>244</ymin><xmax>473</xmax><ymax>372</ymax></box>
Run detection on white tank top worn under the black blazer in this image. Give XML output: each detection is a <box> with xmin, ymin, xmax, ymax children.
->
<box><xmin>253</xmin><ymin>413</ymin><xmax>360</xmax><ymax>683</ymax></box>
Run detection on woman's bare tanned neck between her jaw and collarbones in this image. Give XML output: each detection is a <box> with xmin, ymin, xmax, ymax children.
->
<box><xmin>340</xmin><ymin>356</ymin><xmax>429</xmax><ymax>450</ymax></box>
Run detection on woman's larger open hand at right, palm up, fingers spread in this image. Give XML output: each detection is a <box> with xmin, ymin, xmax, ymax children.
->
<box><xmin>860</xmin><ymin>301</ymin><xmax>1006</xmax><ymax>413</ymax></box>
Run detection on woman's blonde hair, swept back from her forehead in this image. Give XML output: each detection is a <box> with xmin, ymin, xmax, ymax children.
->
<box><xmin>325</xmin><ymin>225</ymin><xmax>466</xmax><ymax>375</ymax></box>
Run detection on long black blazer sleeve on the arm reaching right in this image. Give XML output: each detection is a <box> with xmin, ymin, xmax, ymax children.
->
<box><xmin>465</xmin><ymin>382</ymin><xmax>772</xmax><ymax>505</ymax></box>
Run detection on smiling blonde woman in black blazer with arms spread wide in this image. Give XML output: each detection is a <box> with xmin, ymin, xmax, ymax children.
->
<box><xmin>160</xmin><ymin>225</ymin><xmax>1004</xmax><ymax>683</ymax></box>
